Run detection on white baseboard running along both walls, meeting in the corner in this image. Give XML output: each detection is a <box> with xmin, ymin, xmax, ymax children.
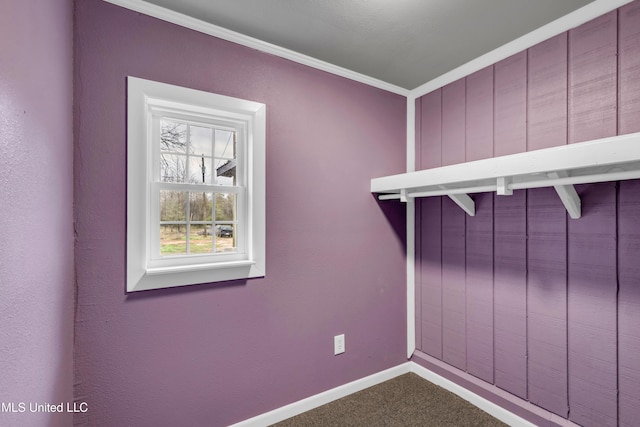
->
<box><xmin>231</xmin><ymin>362</ymin><xmax>535</xmax><ymax>427</ymax></box>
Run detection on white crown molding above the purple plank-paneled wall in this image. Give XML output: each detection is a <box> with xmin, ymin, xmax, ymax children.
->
<box><xmin>409</xmin><ymin>0</ymin><xmax>633</xmax><ymax>98</ymax></box>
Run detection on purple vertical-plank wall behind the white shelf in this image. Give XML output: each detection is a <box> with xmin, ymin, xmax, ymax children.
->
<box><xmin>416</xmin><ymin>1</ymin><xmax>640</xmax><ymax>426</ymax></box>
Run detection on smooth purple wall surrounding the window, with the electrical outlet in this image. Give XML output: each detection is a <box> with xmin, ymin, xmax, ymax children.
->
<box><xmin>75</xmin><ymin>0</ymin><xmax>406</xmax><ymax>426</ymax></box>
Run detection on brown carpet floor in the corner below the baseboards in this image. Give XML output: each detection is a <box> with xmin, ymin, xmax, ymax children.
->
<box><xmin>274</xmin><ymin>373</ymin><xmax>506</xmax><ymax>427</ymax></box>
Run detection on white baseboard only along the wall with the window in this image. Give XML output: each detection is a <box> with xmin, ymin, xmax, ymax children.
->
<box><xmin>230</xmin><ymin>362</ymin><xmax>414</xmax><ymax>427</ymax></box>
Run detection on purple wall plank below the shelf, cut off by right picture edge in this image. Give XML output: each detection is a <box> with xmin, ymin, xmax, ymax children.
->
<box><xmin>618</xmin><ymin>180</ymin><xmax>640</xmax><ymax>427</ymax></box>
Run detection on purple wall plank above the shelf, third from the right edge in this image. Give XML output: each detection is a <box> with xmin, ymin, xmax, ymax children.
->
<box><xmin>527</xmin><ymin>33</ymin><xmax>567</xmax><ymax>151</ymax></box>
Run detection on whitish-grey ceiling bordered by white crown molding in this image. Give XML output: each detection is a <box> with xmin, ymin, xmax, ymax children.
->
<box><xmin>141</xmin><ymin>0</ymin><xmax>592</xmax><ymax>89</ymax></box>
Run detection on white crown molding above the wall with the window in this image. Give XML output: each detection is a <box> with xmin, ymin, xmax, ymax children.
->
<box><xmin>104</xmin><ymin>0</ymin><xmax>409</xmax><ymax>96</ymax></box>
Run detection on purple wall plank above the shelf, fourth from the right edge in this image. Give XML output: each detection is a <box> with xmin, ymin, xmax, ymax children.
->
<box><xmin>493</xmin><ymin>51</ymin><xmax>527</xmax><ymax>156</ymax></box>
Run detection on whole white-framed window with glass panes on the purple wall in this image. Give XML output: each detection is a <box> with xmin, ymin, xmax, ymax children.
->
<box><xmin>127</xmin><ymin>77</ymin><xmax>265</xmax><ymax>292</ymax></box>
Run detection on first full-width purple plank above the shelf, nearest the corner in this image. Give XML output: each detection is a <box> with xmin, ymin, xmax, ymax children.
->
<box><xmin>417</xmin><ymin>89</ymin><xmax>442</xmax><ymax>169</ymax></box>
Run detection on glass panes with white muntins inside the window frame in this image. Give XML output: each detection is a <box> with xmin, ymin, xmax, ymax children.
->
<box><xmin>152</xmin><ymin>115</ymin><xmax>246</xmax><ymax>259</ymax></box>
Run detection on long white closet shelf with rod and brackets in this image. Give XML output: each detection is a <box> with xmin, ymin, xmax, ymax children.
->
<box><xmin>371</xmin><ymin>132</ymin><xmax>640</xmax><ymax>218</ymax></box>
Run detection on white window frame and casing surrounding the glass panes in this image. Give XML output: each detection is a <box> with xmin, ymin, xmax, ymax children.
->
<box><xmin>126</xmin><ymin>76</ymin><xmax>266</xmax><ymax>292</ymax></box>
